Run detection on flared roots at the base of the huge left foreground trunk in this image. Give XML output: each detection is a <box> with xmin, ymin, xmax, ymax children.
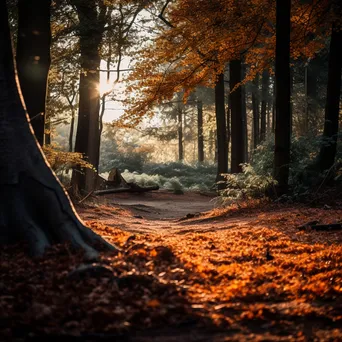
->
<box><xmin>0</xmin><ymin>175</ymin><xmax>119</xmax><ymax>261</ymax></box>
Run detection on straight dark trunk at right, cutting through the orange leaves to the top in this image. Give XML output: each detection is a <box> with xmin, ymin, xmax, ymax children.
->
<box><xmin>274</xmin><ymin>0</ymin><xmax>291</xmax><ymax>195</ymax></box>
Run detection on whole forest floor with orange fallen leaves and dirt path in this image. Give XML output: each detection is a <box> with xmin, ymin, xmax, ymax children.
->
<box><xmin>0</xmin><ymin>191</ymin><xmax>342</xmax><ymax>342</ymax></box>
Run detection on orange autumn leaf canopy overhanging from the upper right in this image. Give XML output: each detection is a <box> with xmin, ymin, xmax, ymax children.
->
<box><xmin>123</xmin><ymin>0</ymin><xmax>330</xmax><ymax>124</ymax></box>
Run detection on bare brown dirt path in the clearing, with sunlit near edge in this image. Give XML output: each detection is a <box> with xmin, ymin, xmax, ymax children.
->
<box><xmin>78</xmin><ymin>191</ymin><xmax>217</xmax><ymax>234</ymax></box>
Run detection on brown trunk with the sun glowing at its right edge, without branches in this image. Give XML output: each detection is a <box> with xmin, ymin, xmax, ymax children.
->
<box><xmin>72</xmin><ymin>0</ymin><xmax>104</xmax><ymax>193</ymax></box>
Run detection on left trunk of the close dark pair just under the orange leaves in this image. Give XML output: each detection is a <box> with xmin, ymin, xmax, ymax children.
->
<box><xmin>215</xmin><ymin>73</ymin><xmax>228</xmax><ymax>189</ymax></box>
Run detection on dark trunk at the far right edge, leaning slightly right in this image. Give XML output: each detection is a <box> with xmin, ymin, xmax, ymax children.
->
<box><xmin>319</xmin><ymin>7</ymin><xmax>342</xmax><ymax>171</ymax></box>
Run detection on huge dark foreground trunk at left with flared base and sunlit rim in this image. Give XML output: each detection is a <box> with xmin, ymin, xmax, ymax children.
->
<box><xmin>0</xmin><ymin>1</ymin><xmax>114</xmax><ymax>258</ymax></box>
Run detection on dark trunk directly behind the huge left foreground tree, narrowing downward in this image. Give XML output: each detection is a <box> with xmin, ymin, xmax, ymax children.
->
<box><xmin>16</xmin><ymin>0</ymin><xmax>51</xmax><ymax>146</ymax></box>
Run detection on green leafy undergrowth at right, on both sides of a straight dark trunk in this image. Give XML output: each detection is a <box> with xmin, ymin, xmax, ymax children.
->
<box><xmin>221</xmin><ymin>135</ymin><xmax>342</xmax><ymax>202</ymax></box>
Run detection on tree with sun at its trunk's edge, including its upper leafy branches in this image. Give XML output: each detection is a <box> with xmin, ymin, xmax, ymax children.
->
<box><xmin>70</xmin><ymin>0</ymin><xmax>145</xmax><ymax>193</ymax></box>
